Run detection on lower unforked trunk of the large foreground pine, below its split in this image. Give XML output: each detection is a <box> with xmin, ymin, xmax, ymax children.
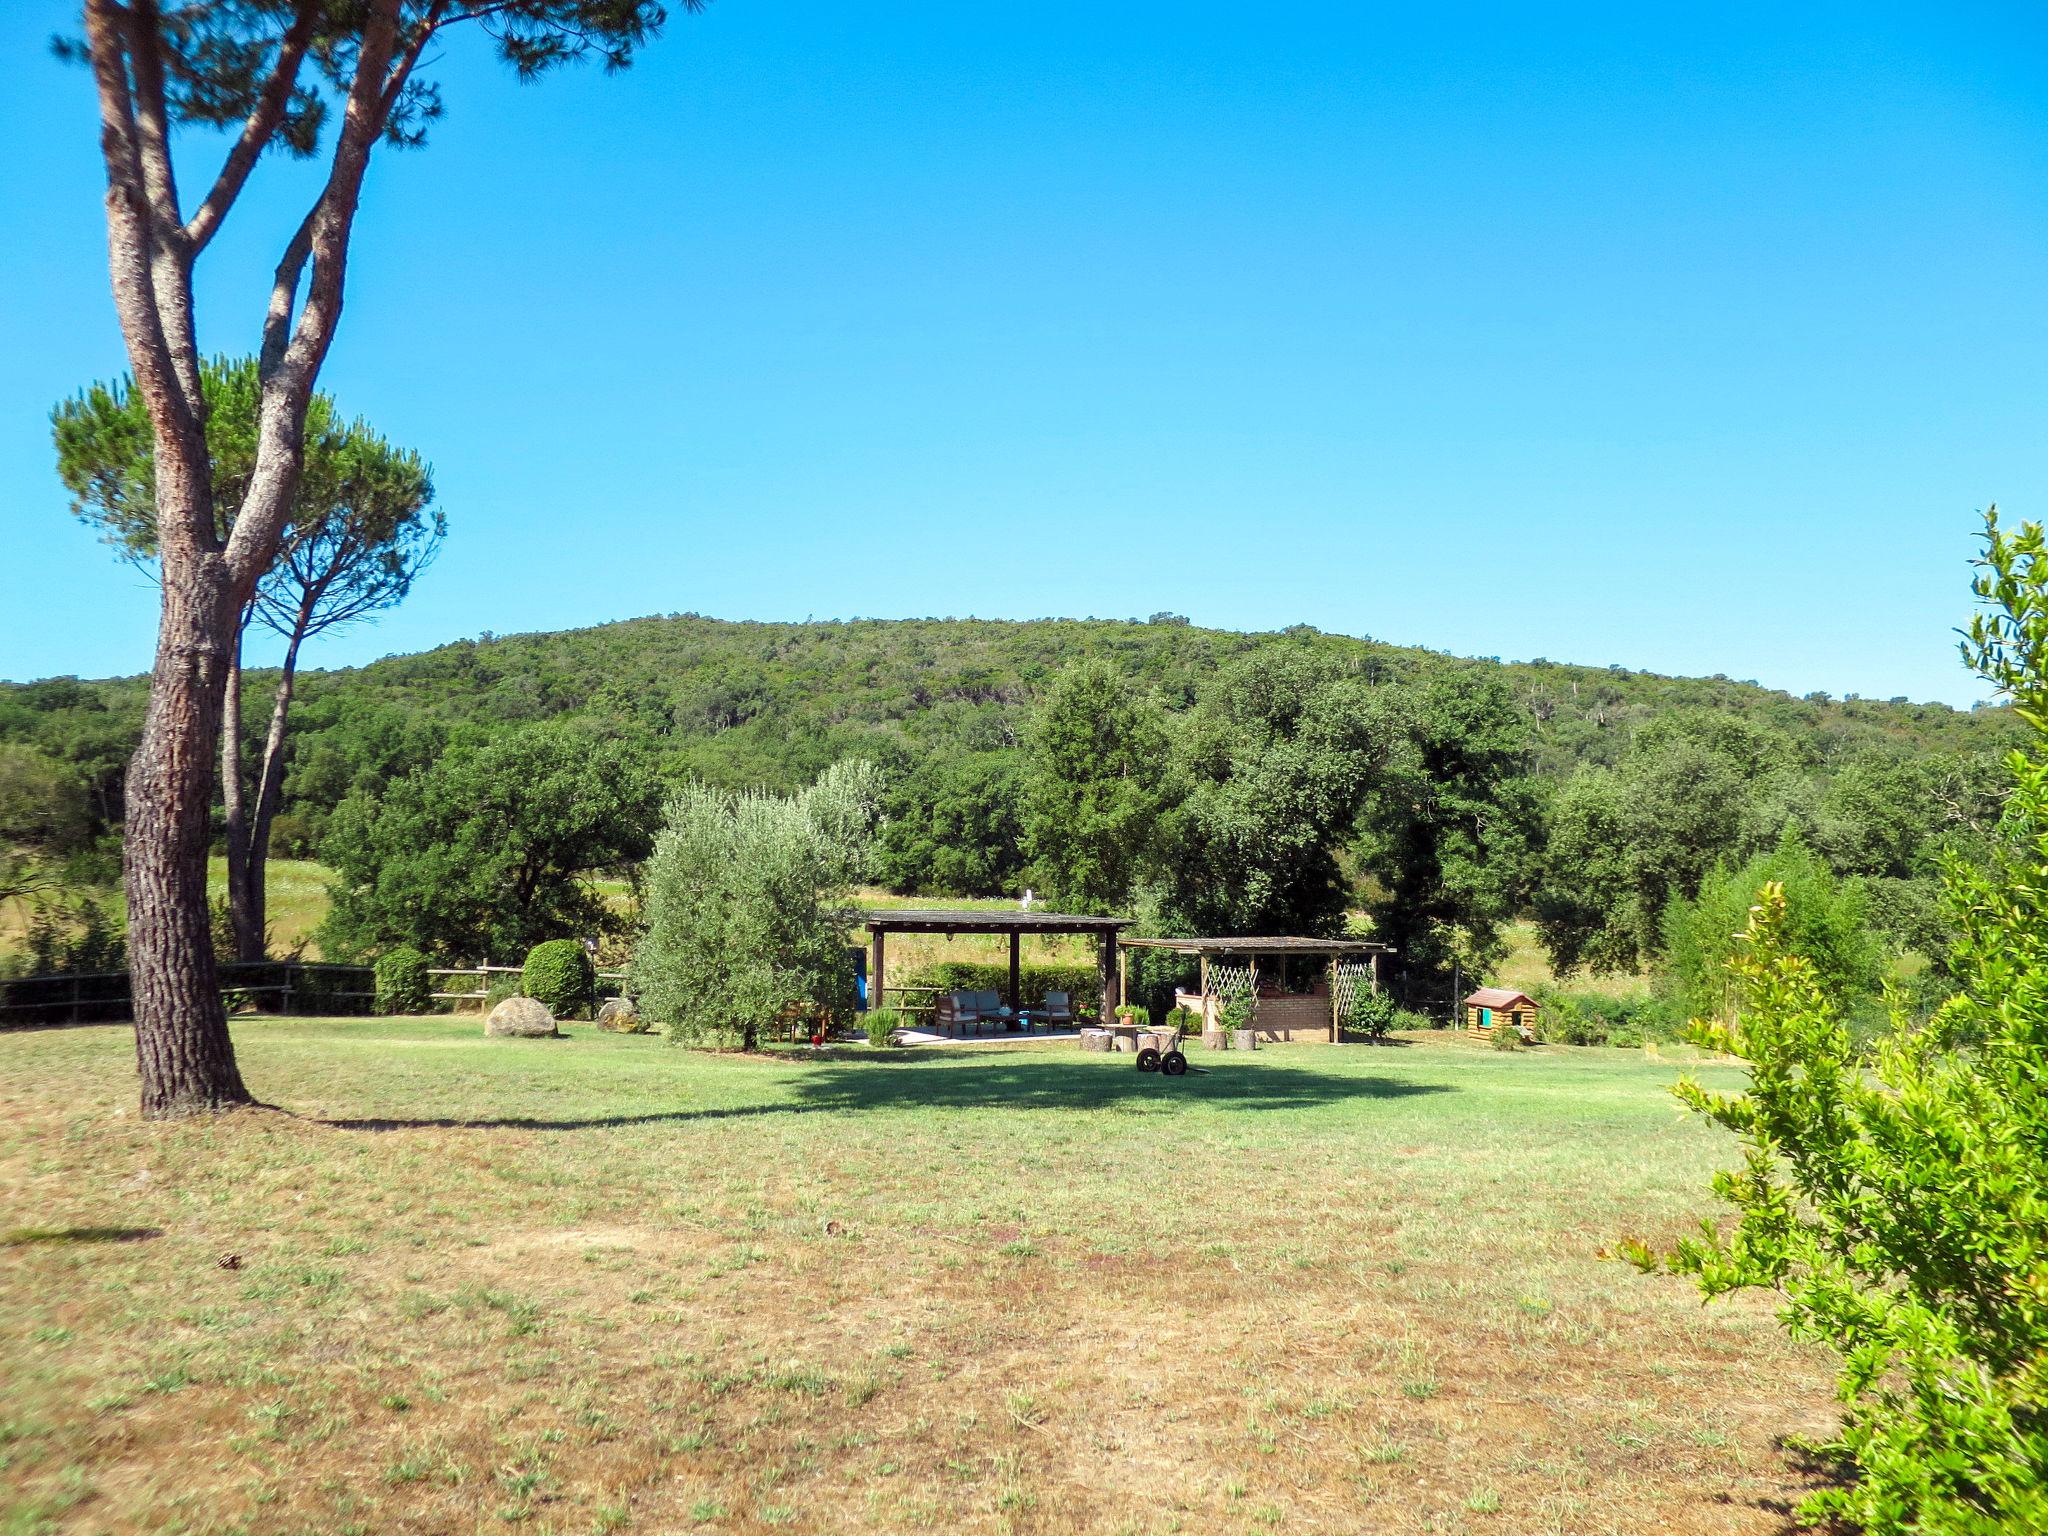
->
<box><xmin>123</xmin><ymin>553</ymin><xmax>252</xmax><ymax>1120</ymax></box>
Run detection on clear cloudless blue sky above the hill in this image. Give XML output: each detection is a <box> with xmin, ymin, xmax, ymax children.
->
<box><xmin>0</xmin><ymin>0</ymin><xmax>2048</xmax><ymax>702</ymax></box>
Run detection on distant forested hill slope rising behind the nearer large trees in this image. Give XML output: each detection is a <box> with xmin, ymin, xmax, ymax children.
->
<box><xmin>0</xmin><ymin>614</ymin><xmax>2013</xmax><ymax>831</ymax></box>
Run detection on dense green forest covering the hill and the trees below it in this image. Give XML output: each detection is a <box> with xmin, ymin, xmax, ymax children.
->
<box><xmin>0</xmin><ymin>614</ymin><xmax>2019</xmax><ymax>1015</ymax></box>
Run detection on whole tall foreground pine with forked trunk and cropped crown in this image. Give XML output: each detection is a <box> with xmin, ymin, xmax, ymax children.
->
<box><xmin>57</xmin><ymin>0</ymin><xmax>698</xmax><ymax>1118</ymax></box>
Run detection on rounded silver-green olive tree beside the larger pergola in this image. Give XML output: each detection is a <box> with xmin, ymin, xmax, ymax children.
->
<box><xmin>633</xmin><ymin>762</ymin><xmax>883</xmax><ymax>1051</ymax></box>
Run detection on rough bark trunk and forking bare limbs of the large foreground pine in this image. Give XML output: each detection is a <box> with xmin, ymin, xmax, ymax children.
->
<box><xmin>86</xmin><ymin>0</ymin><xmax>411</xmax><ymax>1118</ymax></box>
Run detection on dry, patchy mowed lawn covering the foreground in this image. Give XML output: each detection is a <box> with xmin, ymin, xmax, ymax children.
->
<box><xmin>0</xmin><ymin>1018</ymin><xmax>1831</xmax><ymax>1536</ymax></box>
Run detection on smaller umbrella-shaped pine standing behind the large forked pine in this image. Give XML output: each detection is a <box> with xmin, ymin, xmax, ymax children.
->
<box><xmin>51</xmin><ymin>358</ymin><xmax>446</xmax><ymax>961</ymax></box>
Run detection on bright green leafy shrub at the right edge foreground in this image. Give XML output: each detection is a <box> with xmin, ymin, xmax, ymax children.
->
<box><xmin>1626</xmin><ymin>508</ymin><xmax>2048</xmax><ymax>1536</ymax></box>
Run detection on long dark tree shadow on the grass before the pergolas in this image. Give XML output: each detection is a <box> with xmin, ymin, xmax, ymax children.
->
<box><xmin>322</xmin><ymin>1055</ymin><xmax>1456</xmax><ymax>1130</ymax></box>
